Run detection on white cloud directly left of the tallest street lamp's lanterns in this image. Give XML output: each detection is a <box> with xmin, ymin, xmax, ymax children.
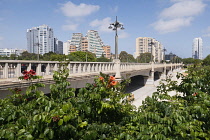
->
<box><xmin>89</xmin><ymin>17</ymin><xmax>112</xmax><ymax>32</ymax></box>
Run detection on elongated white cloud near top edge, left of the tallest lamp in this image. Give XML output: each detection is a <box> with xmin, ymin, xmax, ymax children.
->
<box><xmin>61</xmin><ymin>1</ymin><xmax>100</xmax><ymax>17</ymax></box>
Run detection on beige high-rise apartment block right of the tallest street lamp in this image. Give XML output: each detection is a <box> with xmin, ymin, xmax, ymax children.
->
<box><xmin>135</xmin><ymin>37</ymin><xmax>163</xmax><ymax>62</ymax></box>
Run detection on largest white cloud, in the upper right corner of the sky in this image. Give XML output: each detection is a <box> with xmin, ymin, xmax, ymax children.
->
<box><xmin>152</xmin><ymin>0</ymin><xmax>206</xmax><ymax>33</ymax></box>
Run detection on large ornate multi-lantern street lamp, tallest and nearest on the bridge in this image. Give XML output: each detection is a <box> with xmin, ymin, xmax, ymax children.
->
<box><xmin>109</xmin><ymin>16</ymin><xmax>125</xmax><ymax>59</ymax></box>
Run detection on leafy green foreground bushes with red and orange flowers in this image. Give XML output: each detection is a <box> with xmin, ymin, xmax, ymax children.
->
<box><xmin>0</xmin><ymin>60</ymin><xmax>210</xmax><ymax>140</ymax></box>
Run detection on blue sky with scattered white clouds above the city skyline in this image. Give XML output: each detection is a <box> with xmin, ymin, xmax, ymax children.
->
<box><xmin>0</xmin><ymin>0</ymin><xmax>210</xmax><ymax>58</ymax></box>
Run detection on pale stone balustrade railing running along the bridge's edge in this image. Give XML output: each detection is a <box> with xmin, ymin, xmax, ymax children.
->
<box><xmin>0</xmin><ymin>60</ymin><xmax>181</xmax><ymax>79</ymax></box>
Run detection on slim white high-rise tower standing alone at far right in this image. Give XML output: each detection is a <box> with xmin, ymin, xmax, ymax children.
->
<box><xmin>192</xmin><ymin>37</ymin><xmax>203</xmax><ymax>59</ymax></box>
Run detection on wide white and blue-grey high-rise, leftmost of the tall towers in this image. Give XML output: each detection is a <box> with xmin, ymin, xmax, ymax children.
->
<box><xmin>27</xmin><ymin>25</ymin><xmax>54</xmax><ymax>54</ymax></box>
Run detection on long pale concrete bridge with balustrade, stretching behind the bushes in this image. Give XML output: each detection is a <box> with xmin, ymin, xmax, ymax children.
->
<box><xmin>0</xmin><ymin>60</ymin><xmax>182</xmax><ymax>98</ymax></box>
